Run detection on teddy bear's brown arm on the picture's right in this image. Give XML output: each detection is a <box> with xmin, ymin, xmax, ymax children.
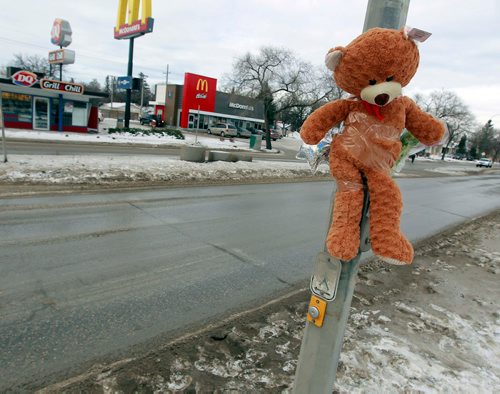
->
<box><xmin>405</xmin><ymin>97</ymin><xmax>445</xmax><ymax>146</ymax></box>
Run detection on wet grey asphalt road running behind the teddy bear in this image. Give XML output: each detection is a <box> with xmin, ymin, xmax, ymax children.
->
<box><xmin>0</xmin><ymin>175</ymin><xmax>500</xmax><ymax>391</ymax></box>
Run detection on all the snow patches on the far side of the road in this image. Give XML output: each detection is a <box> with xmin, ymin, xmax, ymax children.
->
<box><xmin>0</xmin><ymin>125</ymin><xmax>492</xmax><ymax>184</ymax></box>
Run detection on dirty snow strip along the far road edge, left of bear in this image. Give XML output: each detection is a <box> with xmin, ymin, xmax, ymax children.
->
<box><xmin>0</xmin><ymin>155</ymin><xmax>328</xmax><ymax>184</ymax></box>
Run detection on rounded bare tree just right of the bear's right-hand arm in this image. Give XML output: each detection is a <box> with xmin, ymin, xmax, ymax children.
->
<box><xmin>415</xmin><ymin>90</ymin><xmax>476</xmax><ymax>160</ymax></box>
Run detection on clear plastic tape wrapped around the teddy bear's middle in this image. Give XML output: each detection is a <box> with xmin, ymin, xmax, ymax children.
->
<box><xmin>296</xmin><ymin>112</ymin><xmax>448</xmax><ymax>174</ymax></box>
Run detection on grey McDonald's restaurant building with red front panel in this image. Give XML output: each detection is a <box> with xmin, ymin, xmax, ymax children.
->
<box><xmin>151</xmin><ymin>73</ymin><xmax>264</xmax><ymax>130</ymax></box>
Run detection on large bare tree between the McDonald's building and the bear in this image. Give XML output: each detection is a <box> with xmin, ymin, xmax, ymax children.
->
<box><xmin>223</xmin><ymin>47</ymin><xmax>338</xmax><ymax>149</ymax></box>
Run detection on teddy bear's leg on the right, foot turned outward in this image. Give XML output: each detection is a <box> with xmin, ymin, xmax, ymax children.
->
<box><xmin>365</xmin><ymin>171</ymin><xmax>413</xmax><ymax>265</ymax></box>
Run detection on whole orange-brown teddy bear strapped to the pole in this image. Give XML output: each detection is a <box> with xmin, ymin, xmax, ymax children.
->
<box><xmin>300</xmin><ymin>28</ymin><xmax>445</xmax><ymax>265</ymax></box>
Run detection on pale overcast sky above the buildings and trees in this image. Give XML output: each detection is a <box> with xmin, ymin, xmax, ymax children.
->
<box><xmin>0</xmin><ymin>0</ymin><xmax>500</xmax><ymax>126</ymax></box>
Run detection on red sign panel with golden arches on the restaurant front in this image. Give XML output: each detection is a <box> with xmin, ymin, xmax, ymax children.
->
<box><xmin>181</xmin><ymin>73</ymin><xmax>217</xmax><ymax>127</ymax></box>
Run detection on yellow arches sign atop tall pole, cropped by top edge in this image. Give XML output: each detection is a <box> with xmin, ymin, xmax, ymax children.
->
<box><xmin>114</xmin><ymin>0</ymin><xmax>154</xmax><ymax>40</ymax></box>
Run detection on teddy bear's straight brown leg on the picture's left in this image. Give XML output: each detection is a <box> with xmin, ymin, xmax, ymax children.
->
<box><xmin>326</xmin><ymin>151</ymin><xmax>363</xmax><ymax>261</ymax></box>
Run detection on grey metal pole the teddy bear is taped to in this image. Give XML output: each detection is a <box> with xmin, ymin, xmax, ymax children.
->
<box><xmin>293</xmin><ymin>0</ymin><xmax>410</xmax><ymax>394</ymax></box>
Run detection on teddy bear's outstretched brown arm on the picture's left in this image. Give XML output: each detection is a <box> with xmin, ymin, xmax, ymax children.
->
<box><xmin>300</xmin><ymin>100</ymin><xmax>351</xmax><ymax>145</ymax></box>
